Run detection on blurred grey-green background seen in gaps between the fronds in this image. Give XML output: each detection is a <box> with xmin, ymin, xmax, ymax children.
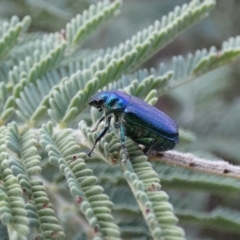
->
<box><xmin>0</xmin><ymin>0</ymin><xmax>240</xmax><ymax>240</ymax></box>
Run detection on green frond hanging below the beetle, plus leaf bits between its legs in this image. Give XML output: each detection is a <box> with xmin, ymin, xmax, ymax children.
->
<box><xmin>80</xmin><ymin>123</ymin><xmax>184</xmax><ymax>239</ymax></box>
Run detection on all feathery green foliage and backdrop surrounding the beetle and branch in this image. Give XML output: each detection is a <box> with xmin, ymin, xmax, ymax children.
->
<box><xmin>0</xmin><ymin>0</ymin><xmax>240</xmax><ymax>240</ymax></box>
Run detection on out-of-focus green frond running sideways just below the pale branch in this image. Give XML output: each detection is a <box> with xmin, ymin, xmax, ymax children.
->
<box><xmin>88</xmin><ymin>159</ymin><xmax>240</xmax><ymax>196</ymax></box>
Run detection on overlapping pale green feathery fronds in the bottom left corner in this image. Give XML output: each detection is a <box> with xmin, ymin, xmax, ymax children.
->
<box><xmin>1</xmin><ymin>123</ymin><xmax>64</xmax><ymax>239</ymax></box>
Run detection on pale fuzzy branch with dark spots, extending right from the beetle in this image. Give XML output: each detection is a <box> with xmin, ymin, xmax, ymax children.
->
<box><xmin>149</xmin><ymin>151</ymin><xmax>240</xmax><ymax>179</ymax></box>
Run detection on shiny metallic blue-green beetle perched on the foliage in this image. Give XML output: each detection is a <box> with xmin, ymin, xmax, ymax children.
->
<box><xmin>88</xmin><ymin>90</ymin><xmax>178</xmax><ymax>160</ymax></box>
